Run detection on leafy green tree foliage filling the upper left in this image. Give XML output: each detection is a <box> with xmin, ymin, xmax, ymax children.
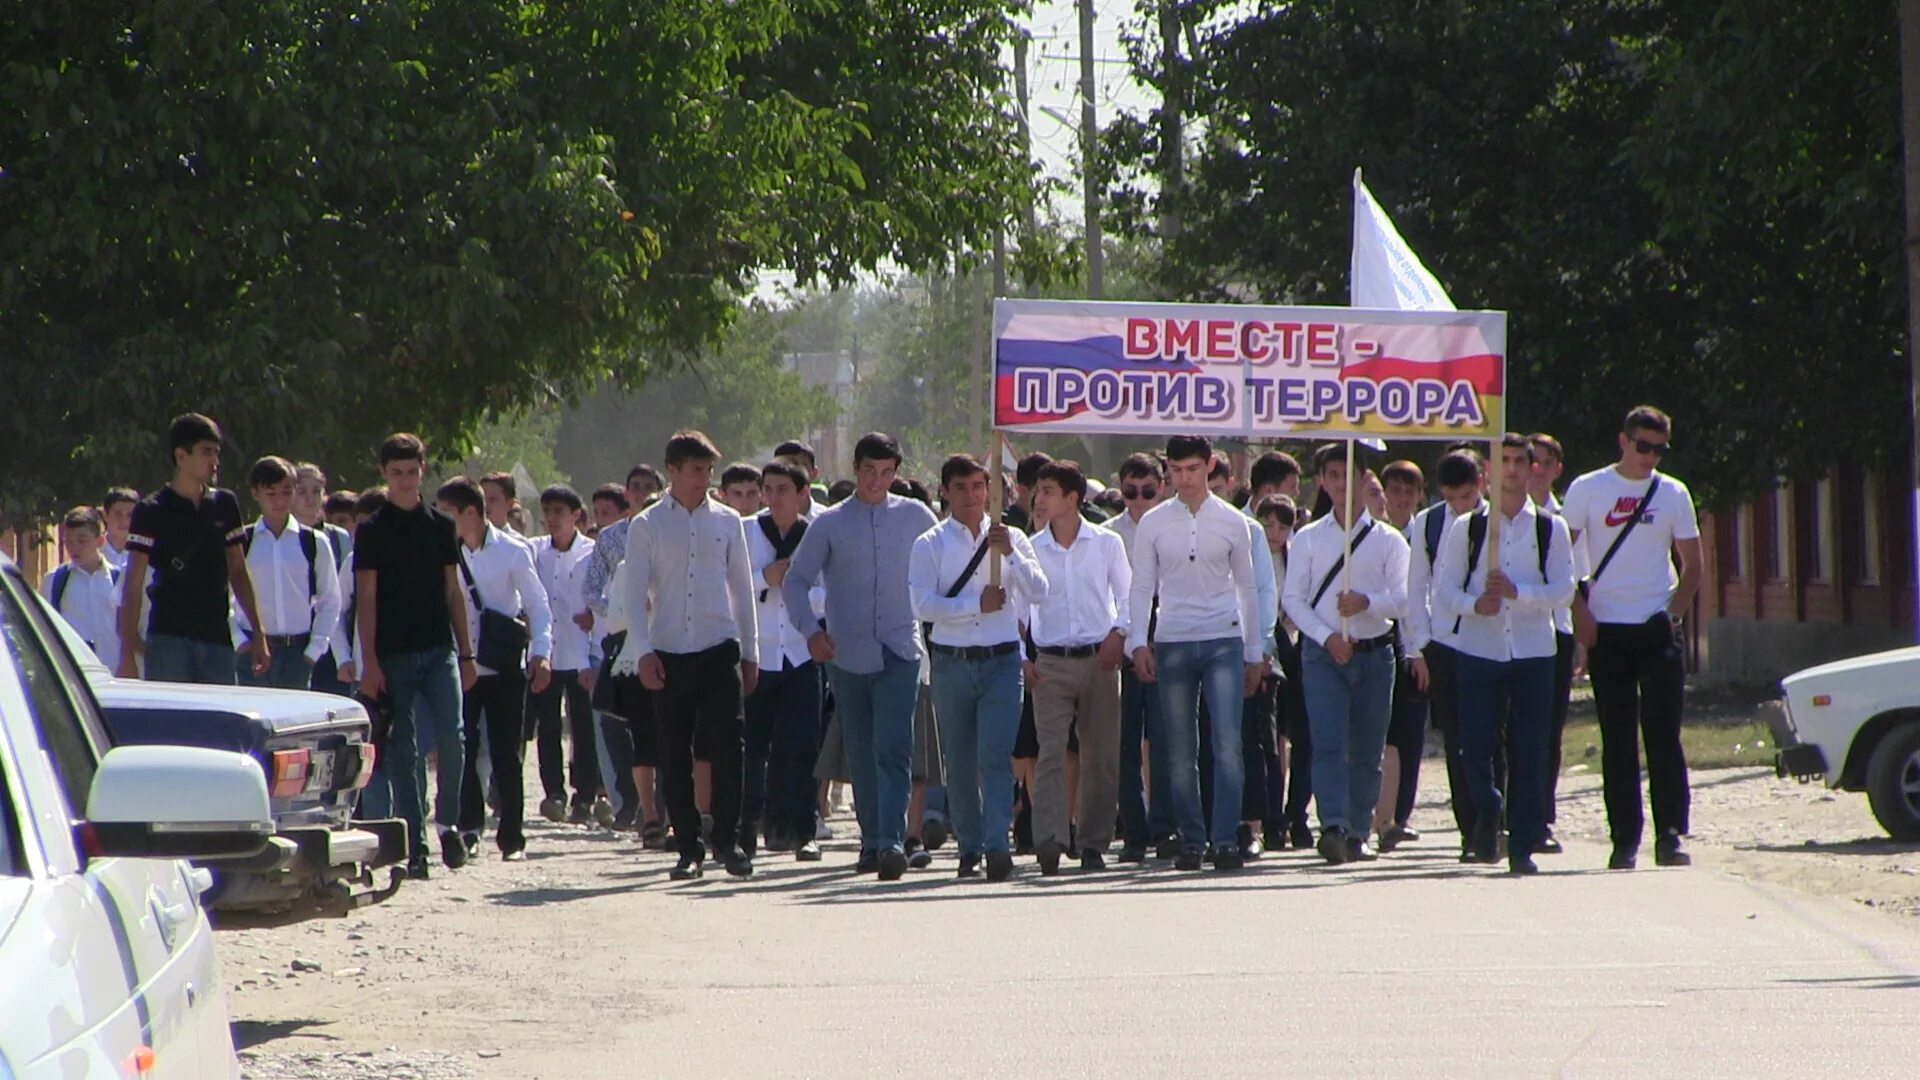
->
<box><xmin>0</xmin><ymin>0</ymin><xmax>1029</xmax><ymax>511</ymax></box>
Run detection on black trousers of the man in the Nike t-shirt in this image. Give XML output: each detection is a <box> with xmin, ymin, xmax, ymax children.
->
<box><xmin>1586</xmin><ymin>613</ymin><xmax>1692</xmax><ymax>847</ymax></box>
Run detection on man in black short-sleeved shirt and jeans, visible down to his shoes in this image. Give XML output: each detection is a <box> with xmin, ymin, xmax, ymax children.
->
<box><xmin>353</xmin><ymin>432</ymin><xmax>480</xmax><ymax>878</ymax></box>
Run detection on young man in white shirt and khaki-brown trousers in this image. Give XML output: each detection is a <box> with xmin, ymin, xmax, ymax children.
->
<box><xmin>1025</xmin><ymin>461</ymin><xmax>1133</xmax><ymax>874</ymax></box>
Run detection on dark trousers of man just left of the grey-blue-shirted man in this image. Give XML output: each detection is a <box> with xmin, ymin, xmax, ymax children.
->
<box><xmin>741</xmin><ymin>661</ymin><xmax>821</xmax><ymax>844</ymax></box>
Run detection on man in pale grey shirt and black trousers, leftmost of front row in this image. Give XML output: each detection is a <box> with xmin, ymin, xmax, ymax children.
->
<box><xmin>624</xmin><ymin>430</ymin><xmax>760</xmax><ymax>880</ymax></box>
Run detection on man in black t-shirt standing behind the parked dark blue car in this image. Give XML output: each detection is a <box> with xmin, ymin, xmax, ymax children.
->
<box><xmin>117</xmin><ymin>413</ymin><xmax>273</xmax><ymax>686</ymax></box>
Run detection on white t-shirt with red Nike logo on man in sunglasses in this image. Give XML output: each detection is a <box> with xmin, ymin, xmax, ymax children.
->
<box><xmin>1561</xmin><ymin>465</ymin><xmax>1699</xmax><ymax>623</ymax></box>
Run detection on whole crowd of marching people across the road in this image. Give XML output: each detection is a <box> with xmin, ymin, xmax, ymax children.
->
<box><xmin>42</xmin><ymin>405</ymin><xmax>1701</xmax><ymax>882</ymax></box>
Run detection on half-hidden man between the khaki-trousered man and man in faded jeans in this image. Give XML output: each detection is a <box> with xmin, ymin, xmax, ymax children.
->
<box><xmin>1108</xmin><ymin>454</ymin><xmax>1181</xmax><ymax>863</ymax></box>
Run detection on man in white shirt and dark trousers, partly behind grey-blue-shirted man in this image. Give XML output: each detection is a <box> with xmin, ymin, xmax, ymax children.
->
<box><xmin>741</xmin><ymin>461</ymin><xmax>826</xmax><ymax>863</ymax></box>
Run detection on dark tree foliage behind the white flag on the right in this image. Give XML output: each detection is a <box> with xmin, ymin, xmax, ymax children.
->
<box><xmin>1108</xmin><ymin>0</ymin><xmax>1907</xmax><ymax>502</ymax></box>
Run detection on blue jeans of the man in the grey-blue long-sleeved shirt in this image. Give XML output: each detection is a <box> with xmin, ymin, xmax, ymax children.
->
<box><xmin>828</xmin><ymin>650</ymin><xmax>920</xmax><ymax>855</ymax></box>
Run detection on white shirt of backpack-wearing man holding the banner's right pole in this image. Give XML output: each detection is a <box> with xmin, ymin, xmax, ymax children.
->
<box><xmin>1432</xmin><ymin>500</ymin><xmax>1572</xmax><ymax>661</ymax></box>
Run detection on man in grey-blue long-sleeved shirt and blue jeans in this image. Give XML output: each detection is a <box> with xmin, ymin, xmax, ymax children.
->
<box><xmin>780</xmin><ymin>432</ymin><xmax>933</xmax><ymax>882</ymax></box>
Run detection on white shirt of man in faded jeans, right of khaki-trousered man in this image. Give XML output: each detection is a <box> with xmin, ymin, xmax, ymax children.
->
<box><xmin>1127</xmin><ymin>496</ymin><xmax>1273</xmax><ymax>663</ymax></box>
